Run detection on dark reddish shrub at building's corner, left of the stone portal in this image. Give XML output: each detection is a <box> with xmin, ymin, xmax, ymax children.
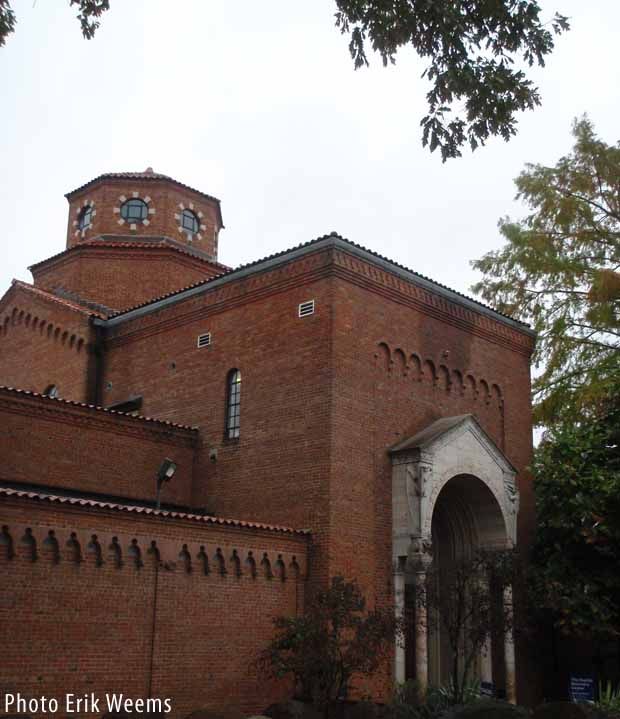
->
<box><xmin>259</xmin><ymin>577</ymin><xmax>399</xmax><ymax>716</ymax></box>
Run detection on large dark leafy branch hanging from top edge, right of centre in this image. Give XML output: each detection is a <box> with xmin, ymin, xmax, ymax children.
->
<box><xmin>336</xmin><ymin>0</ymin><xmax>569</xmax><ymax>162</ymax></box>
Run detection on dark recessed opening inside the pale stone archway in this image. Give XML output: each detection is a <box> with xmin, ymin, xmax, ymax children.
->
<box><xmin>428</xmin><ymin>474</ymin><xmax>507</xmax><ymax>686</ymax></box>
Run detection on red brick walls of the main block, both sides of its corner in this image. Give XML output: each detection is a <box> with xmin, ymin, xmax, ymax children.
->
<box><xmin>98</xmin><ymin>248</ymin><xmax>534</xmax><ymax>704</ymax></box>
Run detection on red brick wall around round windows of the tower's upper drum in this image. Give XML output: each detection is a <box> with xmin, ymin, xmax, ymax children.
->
<box><xmin>67</xmin><ymin>179</ymin><xmax>220</xmax><ymax>259</ymax></box>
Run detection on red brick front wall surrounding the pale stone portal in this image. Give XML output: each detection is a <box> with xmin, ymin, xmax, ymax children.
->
<box><xmin>329</xmin><ymin>268</ymin><xmax>534</xmax><ymax>693</ymax></box>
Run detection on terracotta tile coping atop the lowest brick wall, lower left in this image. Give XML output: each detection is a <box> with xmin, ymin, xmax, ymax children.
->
<box><xmin>0</xmin><ymin>486</ymin><xmax>310</xmax><ymax>536</ymax></box>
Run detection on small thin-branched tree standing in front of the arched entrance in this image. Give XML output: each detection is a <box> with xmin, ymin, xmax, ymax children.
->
<box><xmin>416</xmin><ymin>549</ymin><xmax>520</xmax><ymax>704</ymax></box>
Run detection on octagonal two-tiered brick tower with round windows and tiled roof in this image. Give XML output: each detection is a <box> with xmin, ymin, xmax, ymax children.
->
<box><xmin>30</xmin><ymin>172</ymin><xmax>226</xmax><ymax>311</ymax></box>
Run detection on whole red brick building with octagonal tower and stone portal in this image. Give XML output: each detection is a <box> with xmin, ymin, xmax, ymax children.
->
<box><xmin>0</xmin><ymin>168</ymin><xmax>535</xmax><ymax>719</ymax></box>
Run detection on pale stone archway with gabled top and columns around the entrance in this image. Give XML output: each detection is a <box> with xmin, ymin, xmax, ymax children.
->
<box><xmin>390</xmin><ymin>415</ymin><xmax>519</xmax><ymax>701</ymax></box>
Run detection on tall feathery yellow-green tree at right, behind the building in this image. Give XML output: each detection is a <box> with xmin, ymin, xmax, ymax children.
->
<box><xmin>472</xmin><ymin>117</ymin><xmax>620</xmax><ymax>424</ymax></box>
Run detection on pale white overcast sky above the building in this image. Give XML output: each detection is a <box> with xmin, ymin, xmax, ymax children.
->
<box><xmin>0</xmin><ymin>0</ymin><xmax>620</xmax><ymax>306</ymax></box>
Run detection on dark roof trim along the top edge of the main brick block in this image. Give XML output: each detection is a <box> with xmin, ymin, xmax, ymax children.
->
<box><xmin>94</xmin><ymin>233</ymin><xmax>536</xmax><ymax>337</ymax></box>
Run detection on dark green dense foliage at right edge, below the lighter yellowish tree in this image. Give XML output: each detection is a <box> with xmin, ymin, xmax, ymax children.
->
<box><xmin>530</xmin><ymin>380</ymin><xmax>620</xmax><ymax>639</ymax></box>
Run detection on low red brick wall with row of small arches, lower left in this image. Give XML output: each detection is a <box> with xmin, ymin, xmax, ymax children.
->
<box><xmin>0</xmin><ymin>501</ymin><xmax>306</xmax><ymax>719</ymax></box>
